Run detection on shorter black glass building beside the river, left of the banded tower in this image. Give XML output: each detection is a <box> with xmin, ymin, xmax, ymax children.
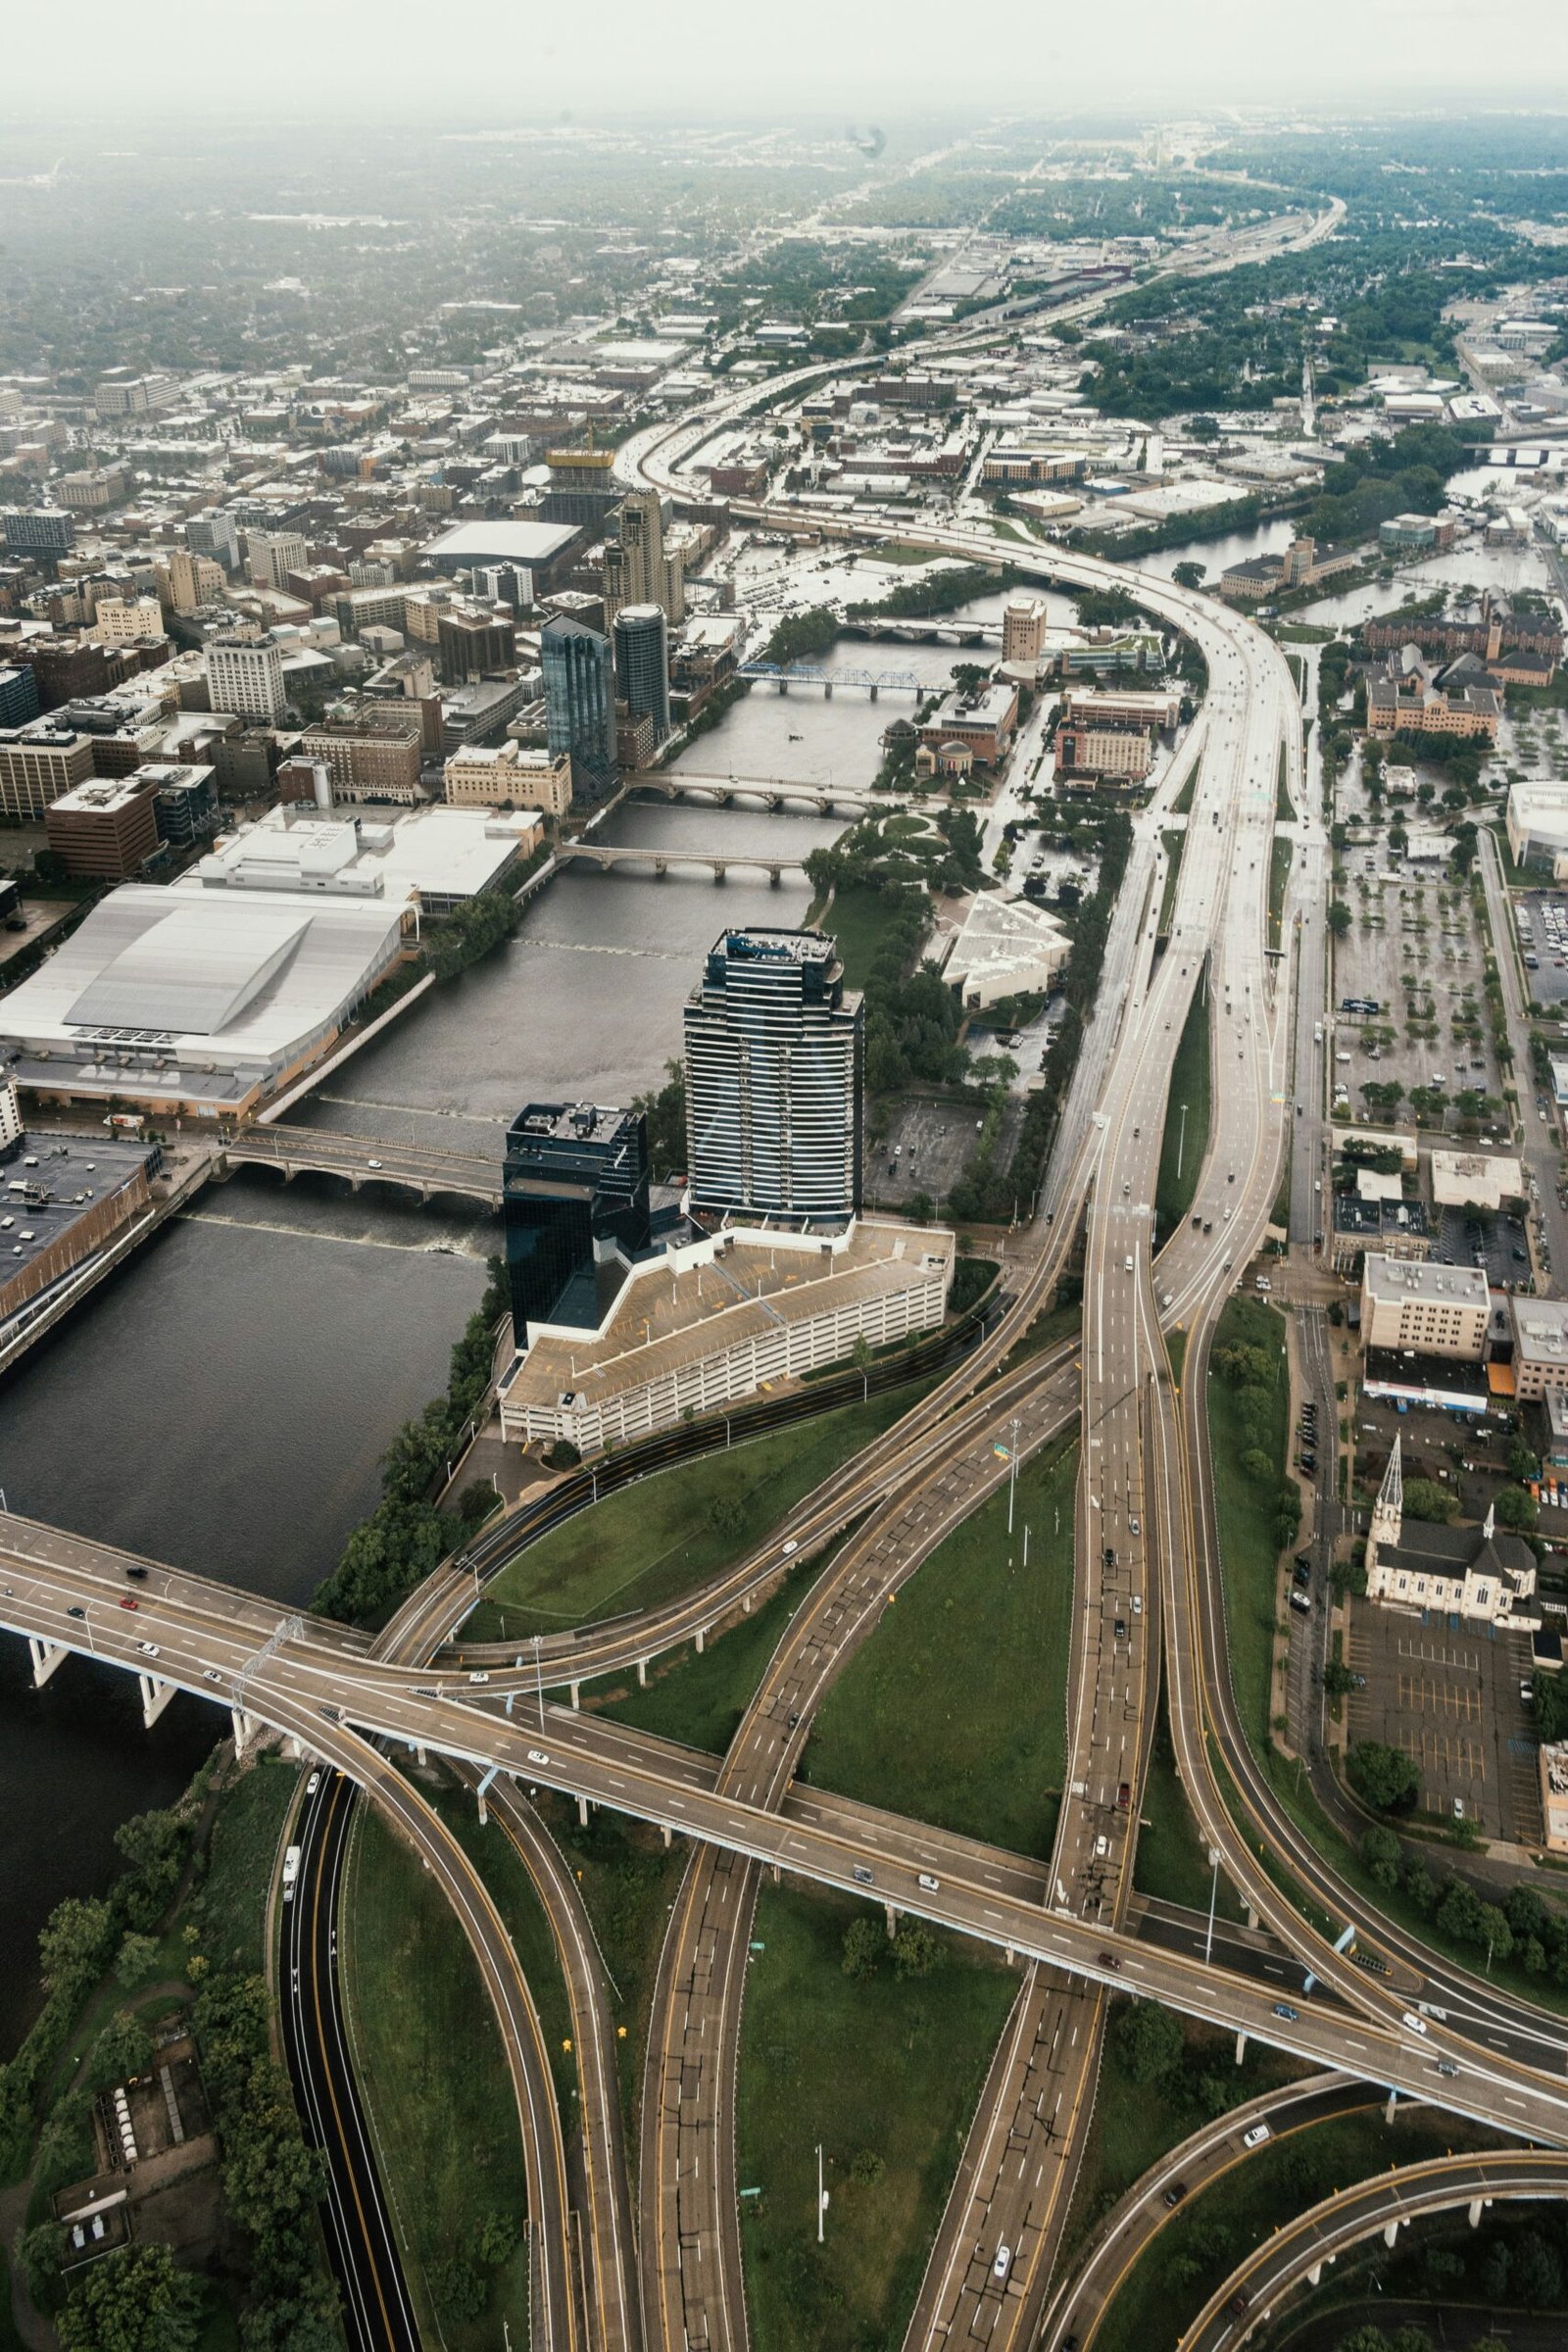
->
<box><xmin>503</xmin><ymin>1103</ymin><xmax>649</xmax><ymax>1348</ymax></box>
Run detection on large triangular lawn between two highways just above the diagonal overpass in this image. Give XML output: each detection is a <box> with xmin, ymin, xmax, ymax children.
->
<box><xmin>804</xmin><ymin>1445</ymin><xmax>1079</xmax><ymax>1853</ymax></box>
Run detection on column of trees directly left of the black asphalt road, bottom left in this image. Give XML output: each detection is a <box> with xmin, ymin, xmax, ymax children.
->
<box><xmin>195</xmin><ymin>1974</ymin><xmax>338</xmax><ymax>2352</ymax></box>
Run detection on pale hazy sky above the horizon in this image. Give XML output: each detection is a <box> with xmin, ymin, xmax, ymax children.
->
<box><xmin>0</xmin><ymin>0</ymin><xmax>1568</xmax><ymax>119</ymax></box>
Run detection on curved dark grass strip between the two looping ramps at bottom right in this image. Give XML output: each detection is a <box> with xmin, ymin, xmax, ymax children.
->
<box><xmin>1096</xmin><ymin>2093</ymin><xmax>1495</xmax><ymax>2352</ymax></box>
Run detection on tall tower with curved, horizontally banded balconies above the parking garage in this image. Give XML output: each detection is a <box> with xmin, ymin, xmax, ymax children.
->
<box><xmin>686</xmin><ymin>931</ymin><xmax>865</xmax><ymax>1223</ymax></box>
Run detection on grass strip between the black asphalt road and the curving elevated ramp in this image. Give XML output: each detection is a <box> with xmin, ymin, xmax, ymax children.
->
<box><xmin>341</xmin><ymin>1806</ymin><xmax>529</xmax><ymax>2352</ymax></box>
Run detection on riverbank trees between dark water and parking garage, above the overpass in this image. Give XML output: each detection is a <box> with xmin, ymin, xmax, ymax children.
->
<box><xmin>311</xmin><ymin>1258</ymin><xmax>508</xmax><ymax>1623</ymax></box>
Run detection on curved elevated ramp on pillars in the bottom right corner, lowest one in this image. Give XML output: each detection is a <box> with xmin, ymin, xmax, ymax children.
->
<box><xmin>1180</xmin><ymin>2147</ymin><xmax>1568</xmax><ymax>2352</ymax></box>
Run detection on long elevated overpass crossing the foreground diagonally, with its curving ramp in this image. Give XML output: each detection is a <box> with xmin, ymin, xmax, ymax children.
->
<box><xmin>2</xmin><ymin>1578</ymin><xmax>1568</xmax><ymax>2154</ymax></box>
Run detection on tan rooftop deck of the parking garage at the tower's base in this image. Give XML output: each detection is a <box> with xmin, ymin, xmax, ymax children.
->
<box><xmin>503</xmin><ymin>1218</ymin><xmax>955</xmax><ymax>1409</ymax></box>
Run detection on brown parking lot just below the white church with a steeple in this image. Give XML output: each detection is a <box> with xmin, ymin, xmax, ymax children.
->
<box><xmin>1348</xmin><ymin>1601</ymin><xmax>1540</xmax><ymax>1846</ymax></box>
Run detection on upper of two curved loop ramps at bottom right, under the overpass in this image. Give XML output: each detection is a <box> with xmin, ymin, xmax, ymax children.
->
<box><xmin>1042</xmin><ymin>2075</ymin><xmax>1385</xmax><ymax>2352</ymax></box>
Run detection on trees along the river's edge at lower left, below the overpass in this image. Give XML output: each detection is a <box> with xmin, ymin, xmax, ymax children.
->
<box><xmin>0</xmin><ymin>1788</ymin><xmax>197</xmax><ymax>2180</ymax></box>
